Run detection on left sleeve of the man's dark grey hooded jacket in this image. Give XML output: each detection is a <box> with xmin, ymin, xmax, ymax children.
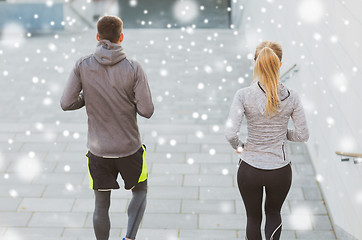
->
<box><xmin>60</xmin><ymin>63</ymin><xmax>85</xmax><ymax>111</ymax></box>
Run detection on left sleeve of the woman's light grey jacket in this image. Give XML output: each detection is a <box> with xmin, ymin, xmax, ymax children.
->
<box><xmin>225</xmin><ymin>90</ymin><xmax>244</xmax><ymax>149</ymax></box>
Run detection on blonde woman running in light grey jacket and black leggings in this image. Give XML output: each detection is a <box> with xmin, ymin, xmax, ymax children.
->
<box><xmin>225</xmin><ymin>41</ymin><xmax>309</xmax><ymax>240</ymax></box>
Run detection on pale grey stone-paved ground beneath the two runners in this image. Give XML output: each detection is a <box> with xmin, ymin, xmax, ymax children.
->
<box><xmin>0</xmin><ymin>15</ymin><xmax>335</xmax><ymax>240</ymax></box>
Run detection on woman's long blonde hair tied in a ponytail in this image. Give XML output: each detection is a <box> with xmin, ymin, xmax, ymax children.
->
<box><xmin>254</xmin><ymin>41</ymin><xmax>283</xmax><ymax>115</ymax></box>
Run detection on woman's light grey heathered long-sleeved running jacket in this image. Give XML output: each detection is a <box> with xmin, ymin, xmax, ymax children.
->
<box><xmin>225</xmin><ymin>82</ymin><xmax>309</xmax><ymax>169</ymax></box>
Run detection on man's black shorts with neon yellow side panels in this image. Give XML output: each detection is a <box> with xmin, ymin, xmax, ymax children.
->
<box><xmin>86</xmin><ymin>145</ymin><xmax>147</xmax><ymax>190</ymax></box>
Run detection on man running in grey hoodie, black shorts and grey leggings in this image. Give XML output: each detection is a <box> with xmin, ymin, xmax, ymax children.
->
<box><xmin>61</xmin><ymin>16</ymin><xmax>154</xmax><ymax>240</ymax></box>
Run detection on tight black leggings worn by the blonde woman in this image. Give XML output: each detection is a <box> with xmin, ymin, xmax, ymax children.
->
<box><xmin>238</xmin><ymin>161</ymin><xmax>292</xmax><ymax>240</ymax></box>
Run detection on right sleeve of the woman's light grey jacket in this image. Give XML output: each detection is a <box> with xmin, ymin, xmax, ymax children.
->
<box><xmin>287</xmin><ymin>91</ymin><xmax>309</xmax><ymax>142</ymax></box>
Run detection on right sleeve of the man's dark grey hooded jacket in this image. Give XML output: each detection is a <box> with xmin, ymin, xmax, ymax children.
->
<box><xmin>133</xmin><ymin>62</ymin><xmax>154</xmax><ymax>118</ymax></box>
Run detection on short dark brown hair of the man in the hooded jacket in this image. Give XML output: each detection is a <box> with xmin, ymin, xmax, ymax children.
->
<box><xmin>97</xmin><ymin>16</ymin><xmax>123</xmax><ymax>43</ymax></box>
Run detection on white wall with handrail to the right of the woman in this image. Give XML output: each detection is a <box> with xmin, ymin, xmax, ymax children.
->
<box><xmin>232</xmin><ymin>0</ymin><xmax>362</xmax><ymax>239</ymax></box>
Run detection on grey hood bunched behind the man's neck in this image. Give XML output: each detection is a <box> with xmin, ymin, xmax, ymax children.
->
<box><xmin>94</xmin><ymin>40</ymin><xmax>126</xmax><ymax>65</ymax></box>
